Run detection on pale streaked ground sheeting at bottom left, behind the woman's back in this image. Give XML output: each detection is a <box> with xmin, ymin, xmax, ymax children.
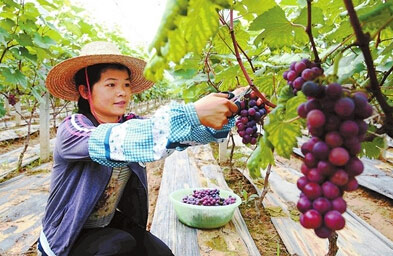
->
<box><xmin>0</xmin><ymin>164</ymin><xmax>51</xmax><ymax>255</ymax></box>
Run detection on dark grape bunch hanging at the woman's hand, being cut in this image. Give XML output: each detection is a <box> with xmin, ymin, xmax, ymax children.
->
<box><xmin>236</xmin><ymin>91</ymin><xmax>267</xmax><ymax>145</ymax></box>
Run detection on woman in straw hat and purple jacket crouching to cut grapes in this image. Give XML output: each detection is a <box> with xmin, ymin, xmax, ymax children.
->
<box><xmin>38</xmin><ymin>42</ymin><xmax>241</xmax><ymax>256</ymax></box>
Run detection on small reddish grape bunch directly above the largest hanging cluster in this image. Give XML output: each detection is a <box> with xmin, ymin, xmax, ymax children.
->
<box><xmin>283</xmin><ymin>59</ymin><xmax>323</xmax><ymax>95</ymax></box>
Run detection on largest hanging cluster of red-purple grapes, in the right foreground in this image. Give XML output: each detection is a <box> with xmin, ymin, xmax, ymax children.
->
<box><xmin>297</xmin><ymin>81</ymin><xmax>373</xmax><ymax>238</ymax></box>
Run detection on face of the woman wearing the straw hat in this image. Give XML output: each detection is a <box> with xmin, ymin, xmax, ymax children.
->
<box><xmin>91</xmin><ymin>69</ymin><xmax>131</xmax><ymax>123</ymax></box>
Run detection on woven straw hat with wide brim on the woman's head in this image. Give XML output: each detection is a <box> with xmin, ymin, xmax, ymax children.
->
<box><xmin>45</xmin><ymin>41</ymin><xmax>154</xmax><ymax>101</ymax></box>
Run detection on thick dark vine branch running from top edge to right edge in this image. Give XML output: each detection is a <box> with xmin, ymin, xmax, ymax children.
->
<box><xmin>343</xmin><ymin>0</ymin><xmax>393</xmax><ymax>138</ymax></box>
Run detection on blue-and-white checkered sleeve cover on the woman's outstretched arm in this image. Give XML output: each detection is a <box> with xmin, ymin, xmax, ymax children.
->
<box><xmin>89</xmin><ymin>102</ymin><xmax>234</xmax><ymax>167</ymax></box>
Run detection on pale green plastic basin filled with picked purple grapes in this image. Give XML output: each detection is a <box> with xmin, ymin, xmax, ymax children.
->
<box><xmin>169</xmin><ymin>188</ymin><xmax>241</xmax><ymax>229</ymax></box>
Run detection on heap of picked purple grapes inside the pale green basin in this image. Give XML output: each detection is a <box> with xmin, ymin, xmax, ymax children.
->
<box><xmin>182</xmin><ymin>188</ymin><xmax>236</xmax><ymax>206</ymax></box>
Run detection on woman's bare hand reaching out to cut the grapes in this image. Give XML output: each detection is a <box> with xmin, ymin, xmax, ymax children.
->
<box><xmin>194</xmin><ymin>93</ymin><xmax>238</xmax><ymax>130</ymax></box>
